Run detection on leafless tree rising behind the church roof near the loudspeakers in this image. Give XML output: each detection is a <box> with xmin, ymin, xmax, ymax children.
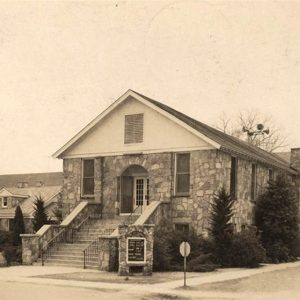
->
<box><xmin>215</xmin><ymin>110</ymin><xmax>288</xmax><ymax>152</ymax></box>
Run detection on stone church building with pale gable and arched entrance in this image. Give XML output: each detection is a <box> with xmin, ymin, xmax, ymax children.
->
<box><xmin>53</xmin><ymin>90</ymin><xmax>300</xmax><ymax>234</ymax></box>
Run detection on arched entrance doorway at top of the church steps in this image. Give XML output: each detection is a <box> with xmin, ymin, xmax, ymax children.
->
<box><xmin>121</xmin><ymin>165</ymin><xmax>149</xmax><ymax>214</ymax></box>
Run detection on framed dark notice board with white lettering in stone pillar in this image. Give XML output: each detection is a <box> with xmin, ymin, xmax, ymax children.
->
<box><xmin>127</xmin><ymin>237</ymin><xmax>146</xmax><ymax>264</ymax></box>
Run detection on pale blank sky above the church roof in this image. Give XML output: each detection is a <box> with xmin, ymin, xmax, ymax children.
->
<box><xmin>0</xmin><ymin>0</ymin><xmax>300</xmax><ymax>174</ymax></box>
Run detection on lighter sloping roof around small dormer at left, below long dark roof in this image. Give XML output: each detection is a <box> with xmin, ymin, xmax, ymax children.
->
<box><xmin>0</xmin><ymin>186</ymin><xmax>61</xmax><ymax>219</ymax></box>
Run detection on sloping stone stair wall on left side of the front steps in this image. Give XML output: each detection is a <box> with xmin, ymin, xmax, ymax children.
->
<box><xmin>21</xmin><ymin>201</ymin><xmax>101</xmax><ymax>265</ymax></box>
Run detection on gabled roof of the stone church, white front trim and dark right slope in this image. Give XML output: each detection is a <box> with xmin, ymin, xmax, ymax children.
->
<box><xmin>53</xmin><ymin>90</ymin><xmax>298</xmax><ymax>174</ymax></box>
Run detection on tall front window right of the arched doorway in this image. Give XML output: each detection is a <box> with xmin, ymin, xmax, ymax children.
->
<box><xmin>176</xmin><ymin>153</ymin><xmax>190</xmax><ymax>195</ymax></box>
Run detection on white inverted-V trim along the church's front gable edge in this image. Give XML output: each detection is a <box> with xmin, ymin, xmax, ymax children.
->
<box><xmin>52</xmin><ymin>90</ymin><xmax>221</xmax><ymax>158</ymax></box>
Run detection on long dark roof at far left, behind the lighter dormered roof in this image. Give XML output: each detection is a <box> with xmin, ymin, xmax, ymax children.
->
<box><xmin>0</xmin><ymin>172</ymin><xmax>63</xmax><ymax>188</ymax></box>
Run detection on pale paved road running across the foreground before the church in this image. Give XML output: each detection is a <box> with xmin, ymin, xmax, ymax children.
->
<box><xmin>0</xmin><ymin>263</ymin><xmax>300</xmax><ymax>300</ymax></box>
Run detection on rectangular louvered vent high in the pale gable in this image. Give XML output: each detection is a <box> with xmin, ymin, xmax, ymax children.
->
<box><xmin>124</xmin><ymin>114</ymin><xmax>144</xmax><ymax>144</ymax></box>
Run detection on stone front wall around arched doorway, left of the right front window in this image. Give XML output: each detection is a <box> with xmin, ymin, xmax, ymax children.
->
<box><xmin>63</xmin><ymin>153</ymin><xmax>173</xmax><ymax>218</ymax></box>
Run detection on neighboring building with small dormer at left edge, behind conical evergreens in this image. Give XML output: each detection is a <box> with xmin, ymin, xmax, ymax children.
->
<box><xmin>0</xmin><ymin>172</ymin><xmax>63</xmax><ymax>232</ymax></box>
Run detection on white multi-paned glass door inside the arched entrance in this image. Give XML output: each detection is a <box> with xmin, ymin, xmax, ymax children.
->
<box><xmin>133</xmin><ymin>177</ymin><xmax>149</xmax><ymax>213</ymax></box>
